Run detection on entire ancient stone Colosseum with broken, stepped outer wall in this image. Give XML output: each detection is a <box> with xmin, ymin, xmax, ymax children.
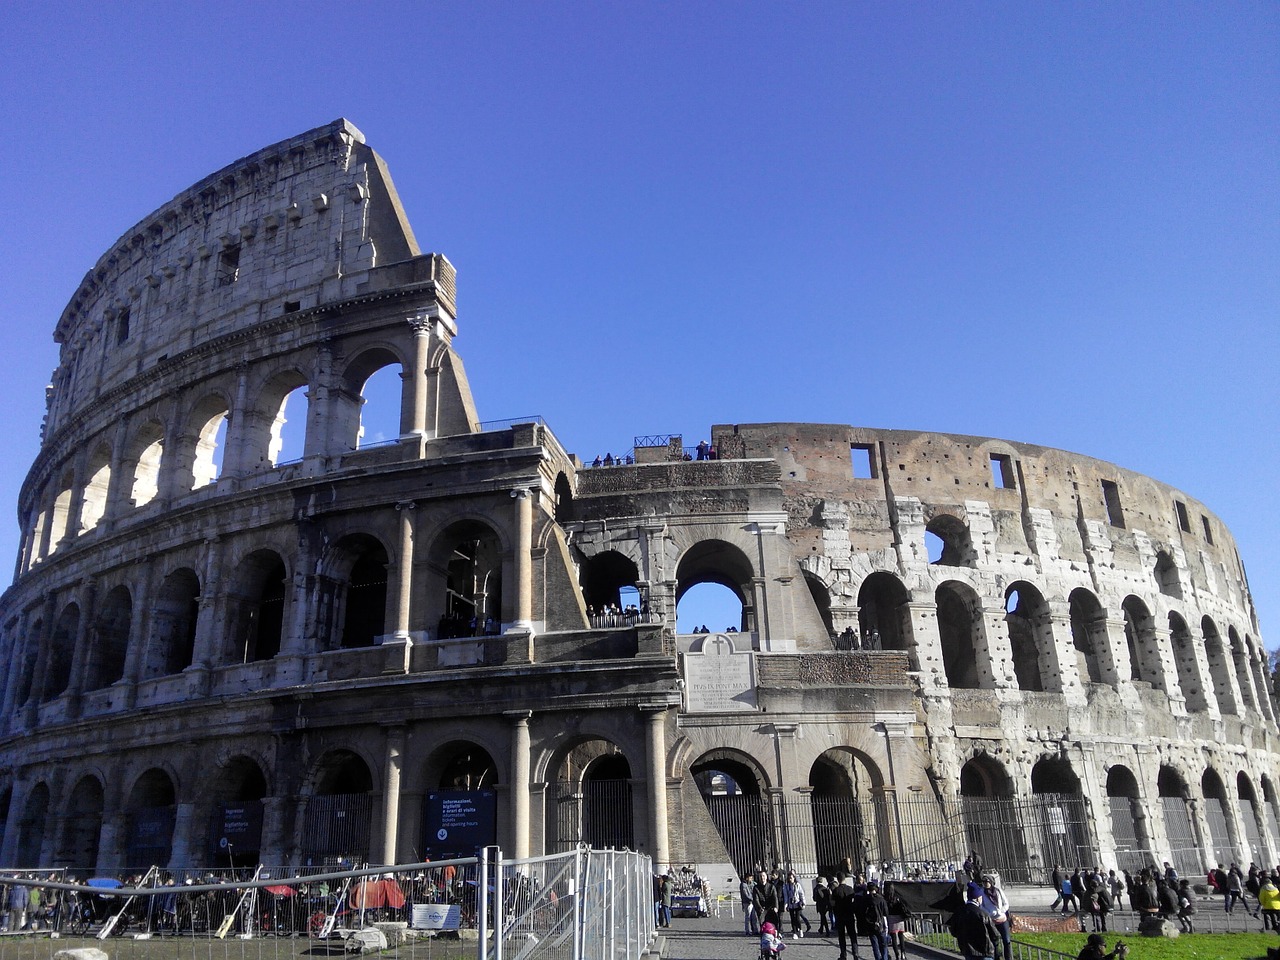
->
<box><xmin>0</xmin><ymin>120</ymin><xmax>1280</xmax><ymax>881</ymax></box>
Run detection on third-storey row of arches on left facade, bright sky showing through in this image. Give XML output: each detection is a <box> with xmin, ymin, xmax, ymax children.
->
<box><xmin>20</xmin><ymin>346</ymin><xmax>406</xmax><ymax>570</ymax></box>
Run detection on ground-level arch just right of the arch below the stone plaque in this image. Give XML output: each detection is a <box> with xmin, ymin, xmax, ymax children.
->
<box><xmin>809</xmin><ymin>748</ymin><xmax>893</xmax><ymax>876</ymax></box>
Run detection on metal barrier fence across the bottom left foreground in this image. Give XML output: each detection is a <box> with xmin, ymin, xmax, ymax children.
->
<box><xmin>0</xmin><ymin>847</ymin><xmax>654</xmax><ymax>960</ymax></box>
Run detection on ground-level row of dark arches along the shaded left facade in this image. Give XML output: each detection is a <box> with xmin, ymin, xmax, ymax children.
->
<box><xmin>0</xmin><ymin>737</ymin><xmax>637</xmax><ymax>870</ymax></box>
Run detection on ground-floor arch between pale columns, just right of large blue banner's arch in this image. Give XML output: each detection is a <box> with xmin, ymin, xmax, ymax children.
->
<box><xmin>553</xmin><ymin>740</ymin><xmax>635</xmax><ymax>850</ymax></box>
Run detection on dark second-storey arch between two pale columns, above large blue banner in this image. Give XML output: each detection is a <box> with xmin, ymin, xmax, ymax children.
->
<box><xmin>431</xmin><ymin>520</ymin><xmax>503</xmax><ymax>640</ymax></box>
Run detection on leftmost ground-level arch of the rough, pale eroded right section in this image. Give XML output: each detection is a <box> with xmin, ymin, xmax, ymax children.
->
<box><xmin>962</xmin><ymin>754</ymin><xmax>1033</xmax><ymax>883</ymax></box>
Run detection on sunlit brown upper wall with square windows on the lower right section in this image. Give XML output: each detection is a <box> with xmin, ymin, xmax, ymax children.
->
<box><xmin>712</xmin><ymin>424</ymin><xmax>1257</xmax><ymax>630</ymax></box>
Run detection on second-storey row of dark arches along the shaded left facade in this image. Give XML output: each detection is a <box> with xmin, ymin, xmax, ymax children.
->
<box><xmin>8</xmin><ymin>520</ymin><xmax>509</xmax><ymax>708</ymax></box>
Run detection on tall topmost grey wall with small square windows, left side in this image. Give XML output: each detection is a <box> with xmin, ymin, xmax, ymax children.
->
<box><xmin>49</xmin><ymin>120</ymin><xmax>453</xmax><ymax>432</ymax></box>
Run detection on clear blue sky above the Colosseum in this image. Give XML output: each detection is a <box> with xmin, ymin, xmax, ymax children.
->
<box><xmin>0</xmin><ymin>1</ymin><xmax>1280</xmax><ymax>646</ymax></box>
